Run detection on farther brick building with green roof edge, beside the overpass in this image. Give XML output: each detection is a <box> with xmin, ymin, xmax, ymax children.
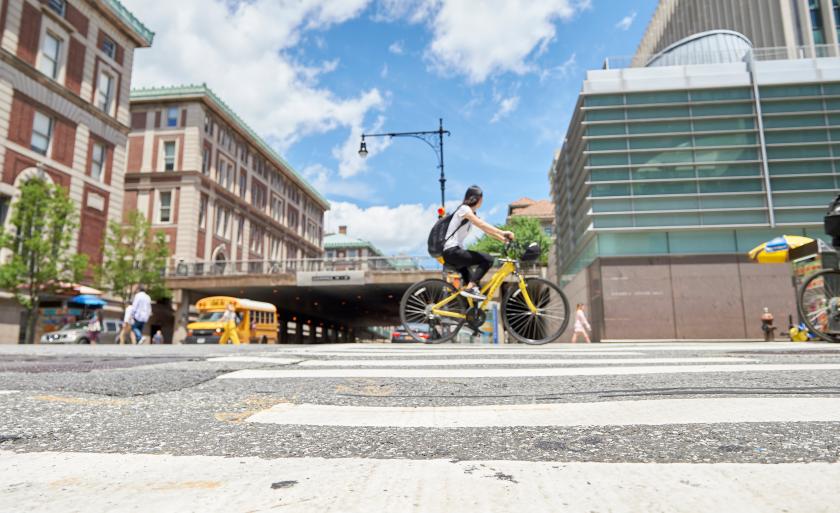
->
<box><xmin>124</xmin><ymin>85</ymin><xmax>329</xmax><ymax>273</ymax></box>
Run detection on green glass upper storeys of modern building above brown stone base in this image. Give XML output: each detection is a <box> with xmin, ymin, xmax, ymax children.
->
<box><xmin>550</xmin><ymin>32</ymin><xmax>840</xmax><ymax>338</ymax></box>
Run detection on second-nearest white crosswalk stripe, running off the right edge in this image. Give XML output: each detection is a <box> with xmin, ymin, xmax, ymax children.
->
<box><xmin>247</xmin><ymin>397</ymin><xmax>840</xmax><ymax>428</ymax></box>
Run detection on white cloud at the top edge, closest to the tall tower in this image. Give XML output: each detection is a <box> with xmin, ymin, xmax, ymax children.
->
<box><xmin>424</xmin><ymin>0</ymin><xmax>588</xmax><ymax>83</ymax></box>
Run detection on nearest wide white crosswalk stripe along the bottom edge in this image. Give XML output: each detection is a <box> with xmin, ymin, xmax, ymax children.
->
<box><xmin>0</xmin><ymin>451</ymin><xmax>840</xmax><ymax>513</ymax></box>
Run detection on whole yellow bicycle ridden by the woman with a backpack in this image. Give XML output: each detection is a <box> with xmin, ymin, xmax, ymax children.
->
<box><xmin>400</xmin><ymin>243</ymin><xmax>569</xmax><ymax>344</ymax></box>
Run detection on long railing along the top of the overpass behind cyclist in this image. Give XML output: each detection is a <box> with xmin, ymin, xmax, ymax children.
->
<box><xmin>166</xmin><ymin>256</ymin><xmax>545</xmax><ymax>278</ymax></box>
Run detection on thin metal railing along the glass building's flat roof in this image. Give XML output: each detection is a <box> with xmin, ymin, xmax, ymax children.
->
<box><xmin>603</xmin><ymin>45</ymin><xmax>840</xmax><ymax>69</ymax></box>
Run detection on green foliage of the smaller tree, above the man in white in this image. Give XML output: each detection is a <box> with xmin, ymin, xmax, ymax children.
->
<box><xmin>97</xmin><ymin>210</ymin><xmax>172</xmax><ymax>304</ymax></box>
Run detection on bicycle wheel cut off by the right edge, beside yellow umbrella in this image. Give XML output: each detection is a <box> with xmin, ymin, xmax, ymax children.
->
<box><xmin>797</xmin><ymin>269</ymin><xmax>840</xmax><ymax>342</ymax></box>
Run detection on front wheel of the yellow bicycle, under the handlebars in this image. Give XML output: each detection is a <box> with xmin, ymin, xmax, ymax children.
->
<box><xmin>502</xmin><ymin>278</ymin><xmax>569</xmax><ymax>344</ymax></box>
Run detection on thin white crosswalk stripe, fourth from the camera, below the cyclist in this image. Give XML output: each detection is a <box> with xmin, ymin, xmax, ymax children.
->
<box><xmin>300</xmin><ymin>357</ymin><xmax>757</xmax><ymax>367</ymax></box>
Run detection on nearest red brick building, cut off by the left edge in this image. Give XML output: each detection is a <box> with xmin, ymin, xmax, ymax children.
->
<box><xmin>0</xmin><ymin>0</ymin><xmax>154</xmax><ymax>342</ymax></box>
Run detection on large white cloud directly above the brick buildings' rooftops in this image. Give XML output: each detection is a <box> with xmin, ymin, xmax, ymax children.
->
<box><xmin>125</xmin><ymin>0</ymin><xmax>385</xmax><ymax>151</ymax></box>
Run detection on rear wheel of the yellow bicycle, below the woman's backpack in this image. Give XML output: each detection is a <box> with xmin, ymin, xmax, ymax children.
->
<box><xmin>400</xmin><ymin>280</ymin><xmax>468</xmax><ymax>344</ymax></box>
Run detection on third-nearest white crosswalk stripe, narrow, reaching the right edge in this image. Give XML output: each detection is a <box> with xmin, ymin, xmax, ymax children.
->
<box><xmin>216</xmin><ymin>363</ymin><xmax>840</xmax><ymax>379</ymax></box>
